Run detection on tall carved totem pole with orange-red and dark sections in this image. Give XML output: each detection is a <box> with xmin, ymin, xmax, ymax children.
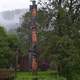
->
<box><xmin>29</xmin><ymin>0</ymin><xmax>38</xmax><ymax>80</ymax></box>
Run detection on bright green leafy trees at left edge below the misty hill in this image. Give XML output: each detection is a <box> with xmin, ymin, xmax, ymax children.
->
<box><xmin>0</xmin><ymin>27</ymin><xmax>17</xmax><ymax>68</ymax></box>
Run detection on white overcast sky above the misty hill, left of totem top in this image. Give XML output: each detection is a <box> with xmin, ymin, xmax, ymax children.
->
<box><xmin>0</xmin><ymin>0</ymin><xmax>38</xmax><ymax>12</ymax></box>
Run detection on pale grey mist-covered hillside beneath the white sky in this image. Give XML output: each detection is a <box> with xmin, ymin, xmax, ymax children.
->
<box><xmin>0</xmin><ymin>9</ymin><xmax>27</xmax><ymax>30</ymax></box>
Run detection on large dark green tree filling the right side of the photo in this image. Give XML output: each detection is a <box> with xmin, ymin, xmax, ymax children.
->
<box><xmin>40</xmin><ymin>0</ymin><xmax>80</xmax><ymax>80</ymax></box>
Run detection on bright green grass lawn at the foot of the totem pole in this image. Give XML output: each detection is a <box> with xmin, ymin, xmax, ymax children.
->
<box><xmin>16</xmin><ymin>71</ymin><xmax>65</xmax><ymax>80</ymax></box>
